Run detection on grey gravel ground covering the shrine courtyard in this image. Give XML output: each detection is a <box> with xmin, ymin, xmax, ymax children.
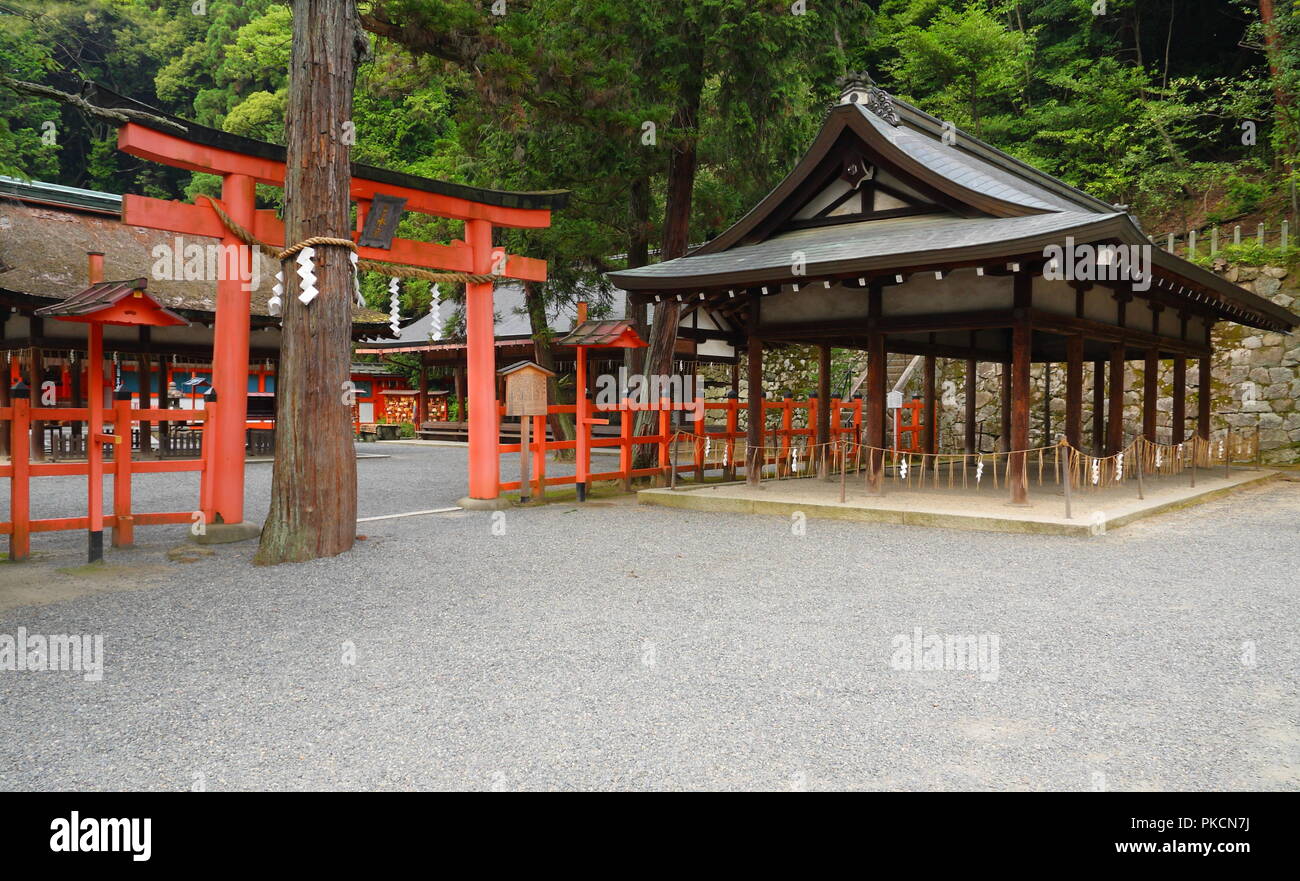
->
<box><xmin>0</xmin><ymin>446</ymin><xmax>1300</xmax><ymax>790</ymax></box>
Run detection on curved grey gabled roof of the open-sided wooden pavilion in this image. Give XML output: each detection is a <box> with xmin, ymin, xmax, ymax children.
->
<box><xmin>610</xmin><ymin>88</ymin><xmax>1300</xmax><ymax>330</ymax></box>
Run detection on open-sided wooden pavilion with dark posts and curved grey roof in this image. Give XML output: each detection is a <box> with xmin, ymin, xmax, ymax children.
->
<box><xmin>610</xmin><ymin>77</ymin><xmax>1300</xmax><ymax>503</ymax></box>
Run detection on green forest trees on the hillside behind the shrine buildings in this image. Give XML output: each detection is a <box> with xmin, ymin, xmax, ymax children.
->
<box><xmin>0</xmin><ymin>0</ymin><xmax>1300</xmax><ymax>327</ymax></box>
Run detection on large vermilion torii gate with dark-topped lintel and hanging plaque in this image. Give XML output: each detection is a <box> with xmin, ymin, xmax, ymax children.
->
<box><xmin>117</xmin><ymin>122</ymin><xmax>563</xmax><ymax>524</ymax></box>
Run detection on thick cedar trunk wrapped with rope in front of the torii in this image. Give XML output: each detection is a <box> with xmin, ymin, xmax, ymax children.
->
<box><xmin>256</xmin><ymin>0</ymin><xmax>365</xmax><ymax>564</ymax></box>
